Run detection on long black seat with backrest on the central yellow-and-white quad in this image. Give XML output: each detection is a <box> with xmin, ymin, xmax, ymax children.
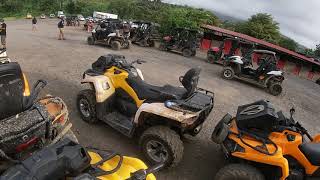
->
<box><xmin>127</xmin><ymin>68</ymin><xmax>200</xmax><ymax>102</ymax></box>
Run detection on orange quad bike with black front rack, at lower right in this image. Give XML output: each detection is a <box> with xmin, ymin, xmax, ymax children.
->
<box><xmin>212</xmin><ymin>101</ymin><xmax>320</xmax><ymax>180</ymax></box>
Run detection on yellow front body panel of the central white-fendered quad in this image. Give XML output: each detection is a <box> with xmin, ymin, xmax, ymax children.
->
<box><xmin>104</xmin><ymin>66</ymin><xmax>145</xmax><ymax>108</ymax></box>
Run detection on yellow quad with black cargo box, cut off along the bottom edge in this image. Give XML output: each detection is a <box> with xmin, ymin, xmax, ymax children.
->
<box><xmin>0</xmin><ymin>138</ymin><xmax>162</xmax><ymax>180</ymax></box>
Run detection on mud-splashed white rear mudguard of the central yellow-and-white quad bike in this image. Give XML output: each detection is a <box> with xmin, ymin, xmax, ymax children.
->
<box><xmin>134</xmin><ymin>103</ymin><xmax>199</xmax><ymax>126</ymax></box>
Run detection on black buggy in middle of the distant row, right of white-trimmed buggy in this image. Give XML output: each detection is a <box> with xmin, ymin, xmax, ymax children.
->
<box><xmin>130</xmin><ymin>21</ymin><xmax>160</xmax><ymax>47</ymax></box>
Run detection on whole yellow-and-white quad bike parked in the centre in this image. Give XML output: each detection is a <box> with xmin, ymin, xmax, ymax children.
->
<box><xmin>77</xmin><ymin>55</ymin><xmax>213</xmax><ymax>167</ymax></box>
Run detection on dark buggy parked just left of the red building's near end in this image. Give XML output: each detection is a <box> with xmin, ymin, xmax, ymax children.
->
<box><xmin>160</xmin><ymin>28</ymin><xmax>199</xmax><ymax>57</ymax></box>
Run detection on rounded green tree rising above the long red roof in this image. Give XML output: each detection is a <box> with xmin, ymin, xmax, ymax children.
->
<box><xmin>235</xmin><ymin>13</ymin><xmax>280</xmax><ymax>44</ymax></box>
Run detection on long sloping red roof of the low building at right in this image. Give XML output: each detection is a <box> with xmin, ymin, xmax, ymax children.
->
<box><xmin>201</xmin><ymin>25</ymin><xmax>320</xmax><ymax>65</ymax></box>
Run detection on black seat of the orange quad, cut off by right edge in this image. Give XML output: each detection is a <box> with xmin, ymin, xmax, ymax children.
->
<box><xmin>299</xmin><ymin>143</ymin><xmax>320</xmax><ymax>166</ymax></box>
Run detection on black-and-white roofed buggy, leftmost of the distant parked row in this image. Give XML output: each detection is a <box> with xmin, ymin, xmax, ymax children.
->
<box><xmin>87</xmin><ymin>20</ymin><xmax>131</xmax><ymax>50</ymax></box>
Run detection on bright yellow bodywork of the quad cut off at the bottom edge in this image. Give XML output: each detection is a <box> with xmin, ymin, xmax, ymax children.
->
<box><xmin>88</xmin><ymin>151</ymin><xmax>156</xmax><ymax>180</ymax></box>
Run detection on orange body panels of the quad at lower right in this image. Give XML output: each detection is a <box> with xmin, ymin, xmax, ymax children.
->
<box><xmin>228</xmin><ymin>120</ymin><xmax>320</xmax><ymax>180</ymax></box>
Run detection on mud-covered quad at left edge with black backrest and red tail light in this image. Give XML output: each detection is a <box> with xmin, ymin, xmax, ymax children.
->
<box><xmin>0</xmin><ymin>58</ymin><xmax>72</xmax><ymax>172</ymax></box>
